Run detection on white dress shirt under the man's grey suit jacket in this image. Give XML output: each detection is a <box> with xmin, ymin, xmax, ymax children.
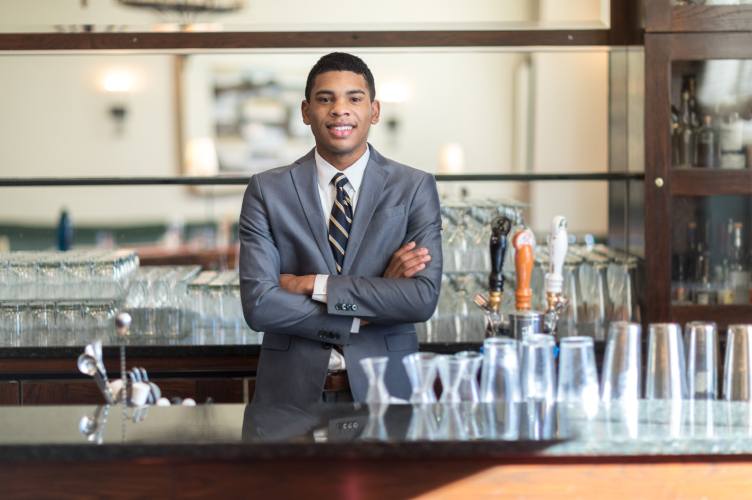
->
<box><xmin>311</xmin><ymin>148</ymin><xmax>371</xmax><ymax>371</ymax></box>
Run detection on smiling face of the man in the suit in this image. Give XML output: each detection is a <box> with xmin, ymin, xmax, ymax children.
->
<box><xmin>302</xmin><ymin>71</ymin><xmax>380</xmax><ymax>156</ymax></box>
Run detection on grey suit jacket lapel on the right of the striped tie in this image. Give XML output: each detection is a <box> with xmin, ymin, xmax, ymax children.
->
<box><xmin>340</xmin><ymin>145</ymin><xmax>387</xmax><ymax>274</ymax></box>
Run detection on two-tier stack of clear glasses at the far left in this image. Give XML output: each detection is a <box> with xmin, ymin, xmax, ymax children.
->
<box><xmin>0</xmin><ymin>250</ymin><xmax>139</xmax><ymax>347</ymax></box>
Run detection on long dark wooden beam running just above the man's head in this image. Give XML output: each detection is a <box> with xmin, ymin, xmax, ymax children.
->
<box><xmin>0</xmin><ymin>29</ymin><xmax>609</xmax><ymax>52</ymax></box>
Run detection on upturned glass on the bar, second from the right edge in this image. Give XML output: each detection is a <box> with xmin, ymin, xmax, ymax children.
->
<box><xmin>684</xmin><ymin>321</ymin><xmax>718</xmax><ymax>399</ymax></box>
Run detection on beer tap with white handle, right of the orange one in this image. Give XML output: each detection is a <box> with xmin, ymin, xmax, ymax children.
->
<box><xmin>543</xmin><ymin>215</ymin><xmax>569</xmax><ymax>335</ymax></box>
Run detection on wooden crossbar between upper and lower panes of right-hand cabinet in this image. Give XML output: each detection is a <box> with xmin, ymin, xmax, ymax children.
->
<box><xmin>671</xmin><ymin>168</ymin><xmax>752</xmax><ymax>196</ymax></box>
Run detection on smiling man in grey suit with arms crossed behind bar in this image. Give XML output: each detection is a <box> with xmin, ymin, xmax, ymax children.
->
<box><xmin>240</xmin><ymin>53</ymin><xmax>442</xmax><ymax>404</ymax></box>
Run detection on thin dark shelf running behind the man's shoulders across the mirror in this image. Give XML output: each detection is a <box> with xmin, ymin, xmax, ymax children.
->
<box><xmin>0</xmin><ymin>172</ymin><xmax>645</xmax><ymax>187</ymax></box>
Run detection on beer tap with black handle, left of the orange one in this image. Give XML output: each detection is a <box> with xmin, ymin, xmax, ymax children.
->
<box><xmin>475</xmin><ymin>217</ymin><xmax>512</xmax><ymax>337</ymax></box>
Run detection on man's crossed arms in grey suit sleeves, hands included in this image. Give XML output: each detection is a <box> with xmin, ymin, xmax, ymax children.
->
<box><xmin>240</xmin><ymin>175</ymin><xmax>442</xmax><ymax>345</ymax></box>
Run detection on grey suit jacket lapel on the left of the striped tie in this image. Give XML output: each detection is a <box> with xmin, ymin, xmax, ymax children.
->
<box><xmin>290</xmin><ymin>151</ymin><xmax>338</xmax><ymax>274</ymax></box>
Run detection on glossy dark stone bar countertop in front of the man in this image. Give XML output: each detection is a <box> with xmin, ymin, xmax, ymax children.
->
<box><xmin>0</xmin><ymin>400</ymin><xmax>752</xmax><ymax>462</ymax></box>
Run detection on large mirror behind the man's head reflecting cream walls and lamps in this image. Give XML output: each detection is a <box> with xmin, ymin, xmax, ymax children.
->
<box><xmin>0</xmin><ymin>50</ymin><xmax>609</xmax><ymax>238</ymax></box>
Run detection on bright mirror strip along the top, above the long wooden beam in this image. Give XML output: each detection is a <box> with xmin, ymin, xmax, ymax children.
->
<box><xmin>0</xmin><ymin>0</ymin><xmax>610</xmax><ymax>33</ymax></box>
